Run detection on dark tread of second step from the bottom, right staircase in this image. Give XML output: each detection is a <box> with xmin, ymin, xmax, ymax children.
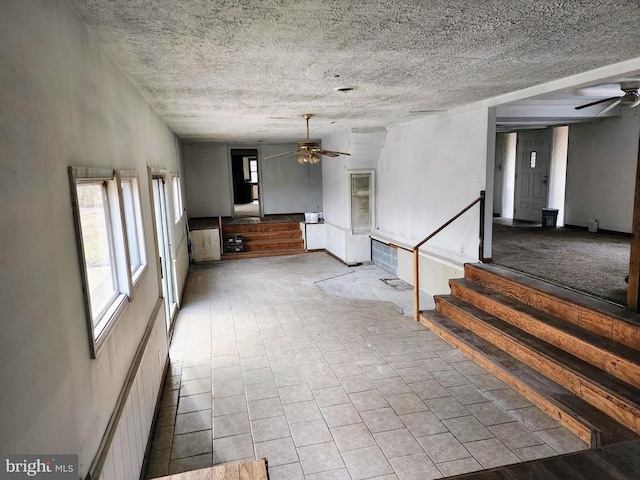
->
<box><xmin>437</xmin><ymin>295</ymin><xmax>640</xmax><ymax>412</ymax></box>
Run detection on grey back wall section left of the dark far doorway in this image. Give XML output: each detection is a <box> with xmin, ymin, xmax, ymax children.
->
<box><xmin>182</xmin><ymin>143</ymin><xmax>233</xmax><ymax>218</ymax></box>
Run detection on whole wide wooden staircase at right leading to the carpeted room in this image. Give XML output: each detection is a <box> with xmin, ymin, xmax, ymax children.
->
<box><xmin>420</xmin><ymin>264</ymin><xmax>640</xmax><ymax>447</ymax></box>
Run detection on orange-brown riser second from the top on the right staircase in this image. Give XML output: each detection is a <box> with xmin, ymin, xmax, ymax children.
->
<box><xmin>451</xmin><ymin>282</ymin><xmax>640</xmax><ymax>387</ymax></box>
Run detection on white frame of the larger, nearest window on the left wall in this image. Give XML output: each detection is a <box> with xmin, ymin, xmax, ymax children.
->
<box><xmin>68</xmin><ymin>167</ymin><xmax>132</xmax><ymax>358</ymax></box>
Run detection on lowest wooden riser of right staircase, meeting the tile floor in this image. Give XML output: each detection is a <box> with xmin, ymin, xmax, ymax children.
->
<box><xmin>420</xmin><ymin>315</ymin><xmax>598</xmax><ymax>447</ymax></box>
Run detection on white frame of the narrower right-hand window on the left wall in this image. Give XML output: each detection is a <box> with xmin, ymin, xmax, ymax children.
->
<box><xmin>116</xmin><ymin>170</ymin><xmax>147</xmax><ymax>286</ymax></box>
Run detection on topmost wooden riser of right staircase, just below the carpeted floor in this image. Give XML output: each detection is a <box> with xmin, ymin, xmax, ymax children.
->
<box><xmin>465</xmin><ymin>265</ymin><xmax>640</xmax><ymax>350</ymax></box>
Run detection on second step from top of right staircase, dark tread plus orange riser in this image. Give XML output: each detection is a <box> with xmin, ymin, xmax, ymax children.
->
<box><xmin>450</xmin><ymin>279</ymin><xmax>640</xmax><ymax>387</ymax></box>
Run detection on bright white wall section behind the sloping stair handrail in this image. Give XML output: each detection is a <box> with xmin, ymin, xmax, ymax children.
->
<box><xmin>377</xmin><ymin>109</ymin><xmax>495</xmax><ymax>293</ymax></box>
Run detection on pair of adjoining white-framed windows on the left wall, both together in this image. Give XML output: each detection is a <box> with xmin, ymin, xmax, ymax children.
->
<box><xmin>69</xmin><ymin>167</ymin><xmax>146</xmax><ymax>358</ymax></box>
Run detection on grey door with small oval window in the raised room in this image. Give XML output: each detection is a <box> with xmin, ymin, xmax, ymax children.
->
<box><xmin>513</xmin><ymin>128</ymin><xmax>551</xmax><ymax>222</ymax></box>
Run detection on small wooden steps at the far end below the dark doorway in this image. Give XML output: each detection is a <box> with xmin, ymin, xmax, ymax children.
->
<box><xmin>222</xmin><ymin>222</ymin><xmax>305</xmax><ymax>260</ymax></box>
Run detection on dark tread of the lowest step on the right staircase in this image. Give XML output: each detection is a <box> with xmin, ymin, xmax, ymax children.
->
<box><xmin>421</xmin><ymin>311</ymin><xmax>637</xmax><ymax>446</ymax></box>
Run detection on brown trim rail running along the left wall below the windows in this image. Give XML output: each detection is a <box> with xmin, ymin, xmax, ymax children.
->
<box><xmin>85</xmin><ymin>298</ymin><xmax>163</xmax><ymax>480</ymax></box>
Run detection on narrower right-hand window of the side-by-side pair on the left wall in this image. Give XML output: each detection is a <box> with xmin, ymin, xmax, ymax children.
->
<box><xmin>118</xmin><ymin>171</ymin><xmax>147</xmax><ymax>285</ymax></box>
